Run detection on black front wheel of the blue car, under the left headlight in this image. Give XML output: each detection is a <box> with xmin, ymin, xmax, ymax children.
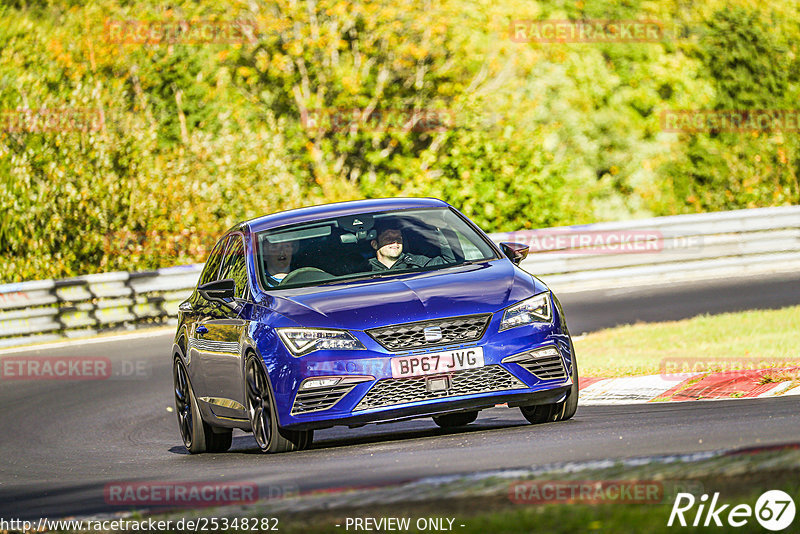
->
<box><xmin>245</xmin><ymin>355</ymin><xmax>314</xmax><ymax>452</ymax></box>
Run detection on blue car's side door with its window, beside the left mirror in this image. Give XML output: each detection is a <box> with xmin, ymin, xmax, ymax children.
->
<box><xmin>196</xmin><ymin>233</ymin><xmax>249</xmax><ymax>418</ymax></box>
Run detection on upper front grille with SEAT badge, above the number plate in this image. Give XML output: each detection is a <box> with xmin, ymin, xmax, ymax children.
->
<box><xmin>366</xmin><ymin>313</ymin><xmax>492</xmax><ymax>352</ymax></box>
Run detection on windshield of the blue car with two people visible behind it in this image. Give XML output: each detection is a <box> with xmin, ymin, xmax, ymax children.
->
<box><xmin>256</xmin><ymin>208</ymin><xmax>497</xmax><ymax>289</ymax></box>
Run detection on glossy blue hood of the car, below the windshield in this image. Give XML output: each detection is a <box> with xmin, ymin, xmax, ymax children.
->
<box><xmin>269</xmin><ymin>260</ymin><xmax>547</xmax><ymax>330</ymax></box>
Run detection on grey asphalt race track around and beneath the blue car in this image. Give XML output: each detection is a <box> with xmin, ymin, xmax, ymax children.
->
<box><xmin>0</xmin><ymin>274</ymin><xmax>800</xmax><ymax>519</ymax></box>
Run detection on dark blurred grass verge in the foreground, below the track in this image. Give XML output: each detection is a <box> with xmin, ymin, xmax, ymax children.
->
<box><xmin>131</xmin><ymin>438</ymin><xmax>800</xmax><ymax>534</ymax></box>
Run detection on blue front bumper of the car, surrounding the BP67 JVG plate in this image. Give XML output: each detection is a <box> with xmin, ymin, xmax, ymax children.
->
<box><xmin>262</xmin><ymin>302</ymin><xmax>574</xmax><ymax>430</ymax></box>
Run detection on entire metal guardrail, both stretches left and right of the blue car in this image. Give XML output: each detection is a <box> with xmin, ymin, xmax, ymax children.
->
<box><xmin>0</xmin><ymin>206</ymin><xmax>800</xmax><ymax>347</ymax></box>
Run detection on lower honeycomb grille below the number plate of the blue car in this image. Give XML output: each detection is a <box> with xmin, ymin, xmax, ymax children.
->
<box><xmin>353</xmin><ymin>365</ymin><xmax>527</xmax><ymax>411</ymax></box>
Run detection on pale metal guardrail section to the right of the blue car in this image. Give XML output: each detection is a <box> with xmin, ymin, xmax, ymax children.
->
<box><xmin>491</xmin><ymin>206</ymin><xmax>800</xmax><ymax>291</ymax></box>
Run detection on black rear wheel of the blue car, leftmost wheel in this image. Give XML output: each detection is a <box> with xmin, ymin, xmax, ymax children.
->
<box><xmin>172</xmin><ymin>358</ymin><xmax>233</xmax><ymax>454</ymax></box>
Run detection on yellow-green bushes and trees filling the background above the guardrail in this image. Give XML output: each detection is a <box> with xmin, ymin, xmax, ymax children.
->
<box><xmin>0</xmin><ymin>0</ymin><xmax>800</xmax><ymax>282</ymax></box>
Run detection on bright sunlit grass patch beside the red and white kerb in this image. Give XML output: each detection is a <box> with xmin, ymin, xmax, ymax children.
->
<box><xmin>575</xmin><ymin>306</ymin><xmax>800</xmax><ymax>381</ymax></box>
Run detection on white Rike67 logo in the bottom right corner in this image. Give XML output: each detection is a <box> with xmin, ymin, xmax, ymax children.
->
<box><xmin>667</xmin><ymin>490</ymin><xmax>796</xmax><ymax>532</ymax></box>
